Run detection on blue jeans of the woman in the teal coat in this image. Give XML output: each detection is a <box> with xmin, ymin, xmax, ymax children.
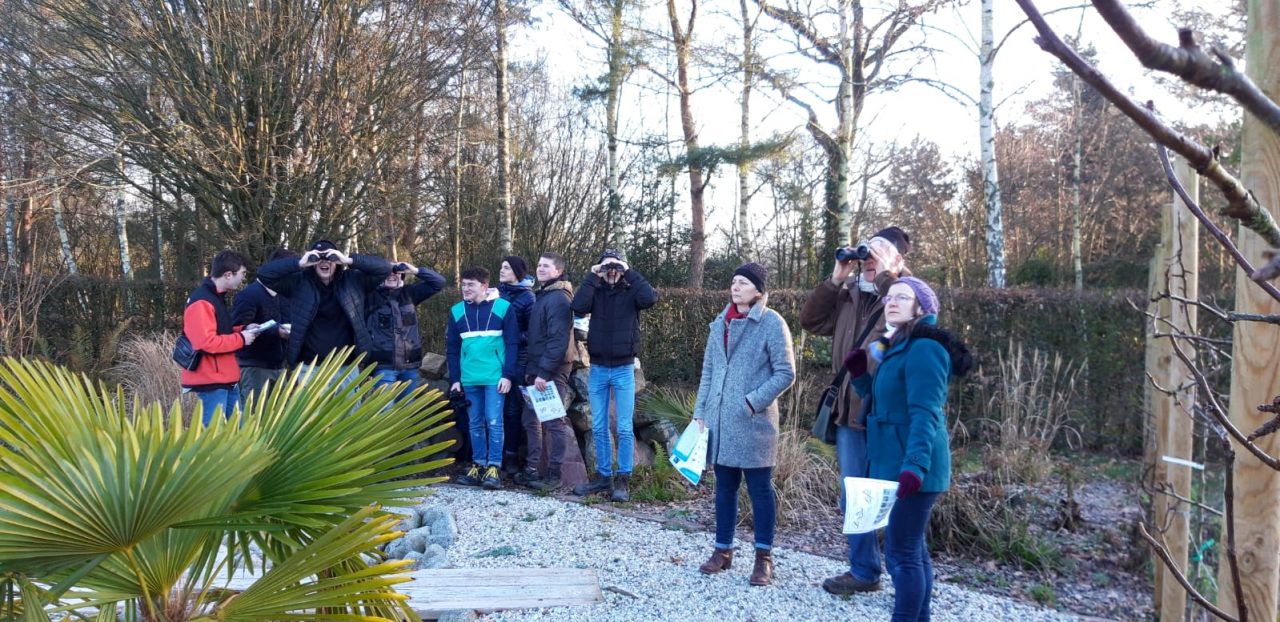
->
<box><xmin>884</xmin><ymin>493</ymin><xmax>941</xmax><ymax>622</ymax></box>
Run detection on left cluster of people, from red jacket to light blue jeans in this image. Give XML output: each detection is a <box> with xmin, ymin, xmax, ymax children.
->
<box><xmin>182</xmin><ymin>239</ymin><xmax>658</xmax><ymax>500</ymax></box>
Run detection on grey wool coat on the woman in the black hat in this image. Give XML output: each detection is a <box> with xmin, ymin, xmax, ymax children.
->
<box><xmin>694</xmin><ymin>296</ymin><xmax>796</xmax><ymax>468</ymax></box>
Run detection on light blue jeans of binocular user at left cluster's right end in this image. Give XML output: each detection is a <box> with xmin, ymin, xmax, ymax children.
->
<box><xmin>588</xmin><ymin>363</ymin><xmax>636</xmax><ymax>477</ymax></box>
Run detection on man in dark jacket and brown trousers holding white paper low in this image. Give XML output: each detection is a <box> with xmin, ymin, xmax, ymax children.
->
<box><xmin>516</xmin><ymin>252</ymin><xmax>576</xmax><ymax>490</ymax></box>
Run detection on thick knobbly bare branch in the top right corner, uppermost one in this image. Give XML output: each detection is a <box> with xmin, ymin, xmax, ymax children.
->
<box><xmin>1093</xmin><ymin>0</ymin><xmax>1280</xmax><ymax>133</ymax></box>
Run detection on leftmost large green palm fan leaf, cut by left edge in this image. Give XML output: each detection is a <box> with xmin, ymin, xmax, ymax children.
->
<box><xmin>0</xmin><ymin>360</ymin><xmax>270</xmax><ymax>572</ymax></box>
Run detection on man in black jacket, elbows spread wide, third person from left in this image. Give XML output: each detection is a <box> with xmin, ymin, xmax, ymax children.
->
<box><xmin>250</xmin><ymin>239</ymin><xmax>392</xmax><ymax>378</ymax></box>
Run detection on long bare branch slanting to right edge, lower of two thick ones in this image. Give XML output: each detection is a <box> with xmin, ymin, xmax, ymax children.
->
<box><xmin>1016</xmin><ymin>0</ymin><xmax>1280</xmax><ymax>247</ymax></box>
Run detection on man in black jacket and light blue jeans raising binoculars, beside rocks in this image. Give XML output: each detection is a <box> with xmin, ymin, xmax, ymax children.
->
<box><xmin>572</xmin><ymin>250</ymin><xmax>658</xmax><ymax>502</ymax></box>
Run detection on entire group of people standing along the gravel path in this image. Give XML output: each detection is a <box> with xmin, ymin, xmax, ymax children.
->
<box><xmin>182</xmin><ymin>227</ymin><xmax>973</xmax><ymax>621</ymax></box>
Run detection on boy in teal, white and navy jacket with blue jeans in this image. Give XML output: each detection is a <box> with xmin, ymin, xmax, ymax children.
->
<box><xmin>445</xmin><ymin>267</ymin><xmax>520</xmax><ymax>490</ymax></box>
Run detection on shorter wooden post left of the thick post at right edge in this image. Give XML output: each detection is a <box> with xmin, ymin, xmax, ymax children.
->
<box><xmin>1148</xmin><ymin>159</ymin><xmax>1199</xmax><ymax>622</ymax></box>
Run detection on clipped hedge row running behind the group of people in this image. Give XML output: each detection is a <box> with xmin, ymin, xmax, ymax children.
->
<box><xmin>41</xmin><ymin>278</ymin><xmax>1144</xmax><ymax>452</ymax></box>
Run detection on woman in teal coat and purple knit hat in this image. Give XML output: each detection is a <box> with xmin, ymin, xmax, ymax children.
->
<box><xmin>845</xmin><ymin>276</ymin><xmax>973</xmax><ymax>622</ymax></box>
